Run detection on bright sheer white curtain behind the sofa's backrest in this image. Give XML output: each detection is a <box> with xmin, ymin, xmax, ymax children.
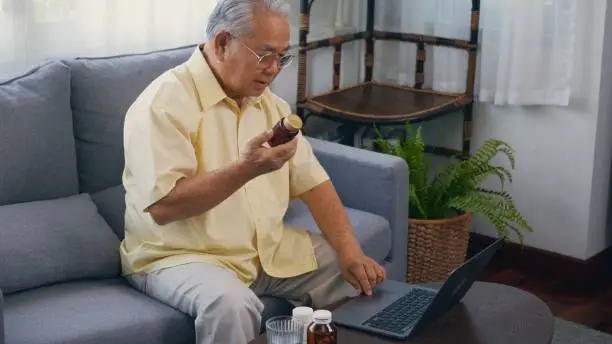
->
<box><xmin>0</xmin><ymin>0</ymin><xmax>216</xmax><ymax>78</ymax></box>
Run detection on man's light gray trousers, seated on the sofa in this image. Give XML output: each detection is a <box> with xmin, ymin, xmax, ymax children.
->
<box><xmin>127</xmin><ymin>235</ymin><xmax>358</xmax><ymax>344</ymax></box>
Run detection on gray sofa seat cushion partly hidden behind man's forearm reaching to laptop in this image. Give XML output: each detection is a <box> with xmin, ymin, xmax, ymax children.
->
<box><xmin>285</xmin><ymin>200</ymin><xmax>391</xmax><ymax>263</ymax></box>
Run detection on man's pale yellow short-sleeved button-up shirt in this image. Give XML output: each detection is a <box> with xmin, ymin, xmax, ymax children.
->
<box><xmin>120</xmin><ymin>45</ymin><xmax>328</xmax><ymax>285</ymax></box>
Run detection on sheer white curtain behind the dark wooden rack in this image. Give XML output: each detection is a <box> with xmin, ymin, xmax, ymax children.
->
<box><xmin>343</xmin><ymin>0</ymin><xmax>586</xmax><ymax>105</ymax></box>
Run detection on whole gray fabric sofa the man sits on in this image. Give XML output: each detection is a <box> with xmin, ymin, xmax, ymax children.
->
<box><xmin>0</xmin><ymin>46</ymin><xmax>408</xmax><ymax>344</ymax></box>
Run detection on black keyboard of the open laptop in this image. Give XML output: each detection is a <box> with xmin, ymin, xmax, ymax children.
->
<box><xmin>363</xmin><ymin>289</ymin><xmax>436</xmax><ymax>333</ymax></box>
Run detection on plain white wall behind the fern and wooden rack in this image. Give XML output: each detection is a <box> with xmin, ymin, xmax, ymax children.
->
<box><xmin>273</xmin><ymin>0</ymin><xmax>612</xmax><ymax>259</ymax></box>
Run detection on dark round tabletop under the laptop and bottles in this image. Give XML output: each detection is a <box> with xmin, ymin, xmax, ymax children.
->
<box><xmin>251</xmin><ymin>282</ymin><xmax>554</xmax><ymax>344</ymax></box>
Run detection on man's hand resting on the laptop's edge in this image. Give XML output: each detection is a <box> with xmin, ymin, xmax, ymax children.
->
<box><xmin>339</xmin><ymin>253</ymin><xmax>385</xmax><ymax>296</ymax></box>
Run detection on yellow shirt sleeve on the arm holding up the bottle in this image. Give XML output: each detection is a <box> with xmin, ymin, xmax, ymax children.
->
<box><xmin>124</xmin><ymin>98</ymin><xmax>197</xmax><ymax>210</ymax></box>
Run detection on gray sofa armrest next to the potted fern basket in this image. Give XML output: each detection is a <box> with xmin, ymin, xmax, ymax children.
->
<box><xmin>308</xmin><ymin>137</ymin><xmax>409</xmax><ymax>281</ymax></box>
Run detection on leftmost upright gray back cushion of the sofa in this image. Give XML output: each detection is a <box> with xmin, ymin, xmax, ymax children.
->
<box><xmin>0</xmin><ymin>62</ymin><xmax>78</xmax><ymax>205</ymax></box>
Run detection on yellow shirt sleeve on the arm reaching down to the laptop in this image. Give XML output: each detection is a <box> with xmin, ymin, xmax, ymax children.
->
<box><xmin>289</xmin><ymin>134</ymin><xmax>329</xmax><ymax>198</ymax></box>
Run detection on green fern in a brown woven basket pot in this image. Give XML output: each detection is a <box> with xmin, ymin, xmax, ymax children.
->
<box><xmin>374</xmin><ymin>124</ymin><xmax>532</xmax><ymax>283</ymax></box>
